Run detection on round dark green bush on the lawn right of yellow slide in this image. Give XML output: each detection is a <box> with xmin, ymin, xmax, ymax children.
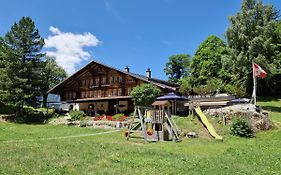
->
<box><xmin>230</xmin><ymin>118</ymin><xmax>254</xmax><ymax>137</ymax></box>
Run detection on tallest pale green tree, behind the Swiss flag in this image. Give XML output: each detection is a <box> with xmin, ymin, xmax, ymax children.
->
<box><xmin>224</xmin><ymin>0</ymin><xmax>281</xmax><ymax>94</ymax></box>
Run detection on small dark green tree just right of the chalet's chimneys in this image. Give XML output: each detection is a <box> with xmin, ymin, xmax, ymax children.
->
<box><xmin>164</xmin><ymin>54</ymin><xmax>191</xmax><ymax>83</ymax></box>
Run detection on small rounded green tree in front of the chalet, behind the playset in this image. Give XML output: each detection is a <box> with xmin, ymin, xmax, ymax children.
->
<box><xmin>131</xmin><ymin>84</ymin><xmax>161</xmax><ymax>106</ymax></box>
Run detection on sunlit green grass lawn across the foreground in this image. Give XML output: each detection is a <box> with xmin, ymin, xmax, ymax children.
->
<box><xmin>0</xmin><ymin>99</ymin><xmax>281</xmax><ymax>174</ymax></box>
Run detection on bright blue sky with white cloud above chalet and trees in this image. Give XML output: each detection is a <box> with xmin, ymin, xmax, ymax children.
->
<box><xmin>0</xmin><ymin>0</ymin><xmax>281</xmax><ymax>79</ymax></box>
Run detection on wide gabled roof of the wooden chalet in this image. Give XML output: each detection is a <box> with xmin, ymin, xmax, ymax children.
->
<box><xmin>48</xmin><ymin>60</ymin><xmax>179</xmax><ymax>93</ymax></box>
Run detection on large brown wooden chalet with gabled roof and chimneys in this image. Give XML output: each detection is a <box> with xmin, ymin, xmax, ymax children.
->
<box><xmin>49</xmin><ymin>61</ymin><xmax>179</xmax><ymax>115</ymax></box>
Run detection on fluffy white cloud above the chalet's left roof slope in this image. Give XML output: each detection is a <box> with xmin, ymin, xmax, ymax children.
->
<box><xmin>44</xmin><ymin>26</ymin><xmax>100</xmax><ymax>75</ymax></box>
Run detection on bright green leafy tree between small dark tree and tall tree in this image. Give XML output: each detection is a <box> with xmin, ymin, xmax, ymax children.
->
<box><xmin>190</xmin><ymin>35</ymin><xmax>227</xmax><ymax>86</ymax></box>
